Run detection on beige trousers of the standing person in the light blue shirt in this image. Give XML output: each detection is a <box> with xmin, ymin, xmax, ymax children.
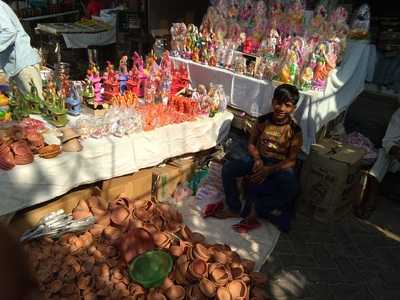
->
<box><xmin>12</xmin><ymin>65</ymin><xmax>43</xmax><ymax>99</ymax></box>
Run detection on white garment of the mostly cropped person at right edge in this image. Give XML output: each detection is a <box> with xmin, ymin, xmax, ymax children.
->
<box><xmin>369</xmin><ymin>108</ymin><xmax>400</xmax><ymax>182</ymax></box>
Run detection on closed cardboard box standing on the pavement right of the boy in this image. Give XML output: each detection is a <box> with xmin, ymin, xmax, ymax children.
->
<box><xmin>300</xmin><ymin>139</ymin><xmax>365</xmax><ymax>219</ymax></box>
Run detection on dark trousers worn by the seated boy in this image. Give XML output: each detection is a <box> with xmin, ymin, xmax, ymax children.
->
<box><xmin>222</xmin><ymin>156</ymin><xmax>298</xmax><ymax>231</ymax></box>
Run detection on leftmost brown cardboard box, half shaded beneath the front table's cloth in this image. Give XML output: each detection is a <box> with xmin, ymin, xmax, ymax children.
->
<box><xmin>10</xmin><ymin>188</ymin><xmax>98</xmax><ymax>237</ymax></box>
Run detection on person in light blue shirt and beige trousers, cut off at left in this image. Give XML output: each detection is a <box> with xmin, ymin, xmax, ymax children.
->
<box><xmin>0</xmin><ymin>0</ymin><xmax>43</xmax><ymax>98</ymax></box>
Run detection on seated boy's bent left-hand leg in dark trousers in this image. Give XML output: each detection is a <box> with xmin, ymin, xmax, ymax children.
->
<box><xmin>222</xmin><ymin>157</ymin><xmax>253</xmax><ymax>215</ymax></box>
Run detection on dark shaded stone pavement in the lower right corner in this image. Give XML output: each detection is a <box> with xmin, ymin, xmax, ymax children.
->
<box><xmin>262</xmin><ymin>214</ymin><xmax>400</xmax><ymax>300</ymax></box>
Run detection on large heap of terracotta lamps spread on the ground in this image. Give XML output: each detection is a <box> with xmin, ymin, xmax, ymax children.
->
<box><xmin>25</xmin><ymin>196</ymin><xmax>268</xmax><ymax>300</ymax></box>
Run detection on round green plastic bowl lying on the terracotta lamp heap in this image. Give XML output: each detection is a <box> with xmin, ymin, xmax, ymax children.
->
<box><xmin>128</xmin><ymin>250</ymin><xmax>173</xmax><ymax>289</ymax></box>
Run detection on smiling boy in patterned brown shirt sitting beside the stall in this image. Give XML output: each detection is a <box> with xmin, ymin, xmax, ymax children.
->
<box><xmin>215</xmin><ymin>84</ymin><xmax>303</xmax><ymax>232</ymax></box>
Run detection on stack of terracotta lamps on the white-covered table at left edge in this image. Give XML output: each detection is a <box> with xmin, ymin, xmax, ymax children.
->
<box><xmin>0</xmin><ymin>126</ymin><xmax>45</xmax><ymax>170</ymax></box>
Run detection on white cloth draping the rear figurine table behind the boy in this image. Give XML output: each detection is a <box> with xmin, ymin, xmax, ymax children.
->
<box><xmin>172</xmin><ymin>40</ymin><xmax>375</xmax><ymax>153</ymax></box>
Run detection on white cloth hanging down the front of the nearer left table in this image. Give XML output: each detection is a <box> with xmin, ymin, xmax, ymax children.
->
<box><xmin>0</xmin><ymin>112</ymin><xmax>233</xmax><ymax>216</ymax></box>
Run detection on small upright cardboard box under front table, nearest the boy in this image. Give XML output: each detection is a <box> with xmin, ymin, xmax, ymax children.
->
<box><xmin>151</xmin><ymin>165</ymin><xmax>181</xmax><ymax>201</ymax></box>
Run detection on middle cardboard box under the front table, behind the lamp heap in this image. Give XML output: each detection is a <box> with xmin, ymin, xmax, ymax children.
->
<box><xmin>102</xmin><ymin>169</ymin><xmax>152</xmax><ymax>202</ymax></box>
